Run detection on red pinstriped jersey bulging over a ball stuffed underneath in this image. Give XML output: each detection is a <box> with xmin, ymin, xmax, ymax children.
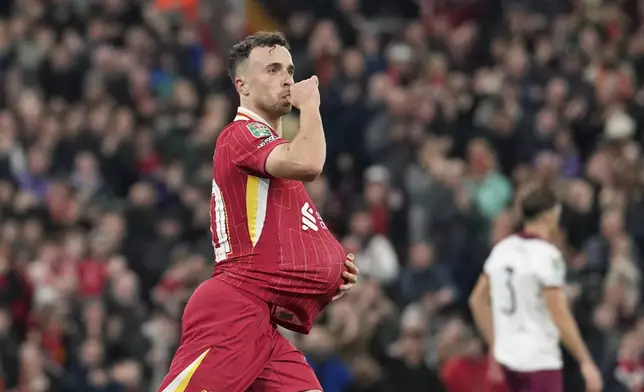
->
<box><xmin>210</xmin><ymin>108</ymin><xmax>346</xmax><ymax>333</ymax></box>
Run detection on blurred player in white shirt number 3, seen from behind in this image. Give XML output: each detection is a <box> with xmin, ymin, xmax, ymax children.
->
<box><xmin>470</xmin><ymin>188</ymin><xmax>602</xmax><ymax>392</ymax></box>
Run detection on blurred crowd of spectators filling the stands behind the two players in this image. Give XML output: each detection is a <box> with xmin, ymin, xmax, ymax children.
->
<box><xmin>0</xmin><ymin>0</ymin><xmax>644</xmax><ymax>392</ymax></box>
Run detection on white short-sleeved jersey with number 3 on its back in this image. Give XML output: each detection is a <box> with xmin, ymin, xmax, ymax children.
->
<box><xmin>483</xmin><ymin>235</ymin><xmax>566</xmax><ymax>372</ymax></box>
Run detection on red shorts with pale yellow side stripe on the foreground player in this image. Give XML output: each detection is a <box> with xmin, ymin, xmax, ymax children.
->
<box><xmin>159</xmin><ymin>279</ymin><xmax>322</xmax><ymax>392</ymax></box>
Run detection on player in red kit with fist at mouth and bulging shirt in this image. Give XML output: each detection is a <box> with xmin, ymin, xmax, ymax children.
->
<box><xmin>159</xmin><ymin>33</ymin><xmax>358</xmax><ymax>392</ymax></box>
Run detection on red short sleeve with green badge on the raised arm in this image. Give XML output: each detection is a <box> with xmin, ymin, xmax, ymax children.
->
<box><xmin>226</xmin><ymin>121</ymin><xmax>287</xmax><ymax>177</ymax></box>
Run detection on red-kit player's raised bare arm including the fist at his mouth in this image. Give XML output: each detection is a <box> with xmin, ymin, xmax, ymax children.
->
<box><xmin>266</xmin><ymin>76</ymin><xmax>326</xmax><ymax>181</ymax></box>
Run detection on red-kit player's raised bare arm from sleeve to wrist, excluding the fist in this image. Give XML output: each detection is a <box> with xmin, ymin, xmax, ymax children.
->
<box><xmin>266</xmin><ymin>105</ymin><xmax>326</xmax><ymax>181</ymax></box>
